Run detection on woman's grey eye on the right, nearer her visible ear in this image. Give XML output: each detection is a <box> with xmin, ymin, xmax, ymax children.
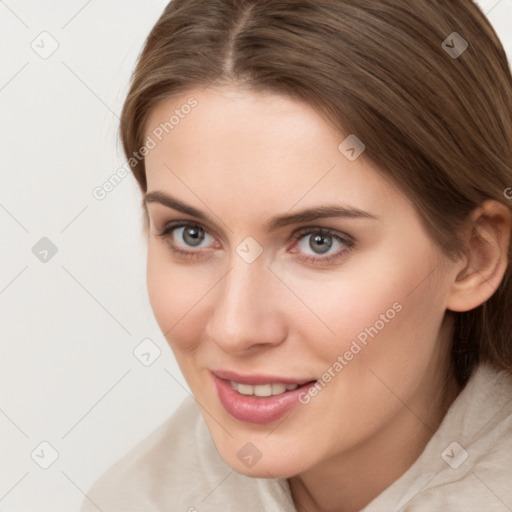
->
<box><xmin>291</xmin><ymin>228</ymin><xmax>355</xmax><ymax>262</ymax></box>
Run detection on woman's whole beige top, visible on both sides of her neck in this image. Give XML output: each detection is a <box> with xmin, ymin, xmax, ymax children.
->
<box><xmin>82</xmin><ymin>364</ymin><xmax>512</xmax><ymax>512</ymax></box>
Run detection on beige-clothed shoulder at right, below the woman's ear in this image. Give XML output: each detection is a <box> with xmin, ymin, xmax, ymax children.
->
<box><xmin>364</xmin><ymin>363</ymin><xmax>512</xmax><ymax>512</ymax></box>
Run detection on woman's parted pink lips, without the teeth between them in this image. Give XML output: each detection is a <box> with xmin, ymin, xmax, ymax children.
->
<box><xmin>212</xmin><ymin>372</ymin><xmax>316</xmax><ymax>425</ymax></box>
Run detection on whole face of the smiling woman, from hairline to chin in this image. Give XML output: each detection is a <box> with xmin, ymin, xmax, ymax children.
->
<box><xmin>146</xmin><ymin>88</ymin><xmax>455</xmax><ymax>477</ymax></box>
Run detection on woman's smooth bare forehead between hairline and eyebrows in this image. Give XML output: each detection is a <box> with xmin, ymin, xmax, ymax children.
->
<box><xmin>146</xmin><ymin>88</ymin><xmax>407</xmax><ymax>223</ymax></box>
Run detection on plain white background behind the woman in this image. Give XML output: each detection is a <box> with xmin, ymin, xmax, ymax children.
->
<box><xmin>0</xmin><ymin>0</ymin><xmax>512</xmax><ymax>512</ymax></box>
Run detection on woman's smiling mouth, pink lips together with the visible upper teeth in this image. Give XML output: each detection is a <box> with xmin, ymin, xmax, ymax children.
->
<box><xmin>212</xmin><ymin>371</ymin><xmax>317</xmax><ymax>425</ymax></box>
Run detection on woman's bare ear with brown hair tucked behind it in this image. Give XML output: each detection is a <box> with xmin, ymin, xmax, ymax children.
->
<box><xmin>446</xmin><ymin>200</ymin><xmax>512</xmax><ymax>312</ymax></box>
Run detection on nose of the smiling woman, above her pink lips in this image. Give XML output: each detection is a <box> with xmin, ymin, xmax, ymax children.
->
<box><xmin>206</xmin><ymin>255</ymin><xmax>287</xmax><ymax>354</ymax></box>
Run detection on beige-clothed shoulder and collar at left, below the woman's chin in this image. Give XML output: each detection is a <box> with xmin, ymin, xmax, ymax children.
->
<box><xmin>81</xmin><ymin>397</ymin><xmax>294</xmax><ymax>512</ymax></box>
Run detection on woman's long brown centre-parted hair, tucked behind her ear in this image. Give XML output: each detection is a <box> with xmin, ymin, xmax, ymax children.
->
<box><xmin>121</xmin><ymin>0</ymin><xmax>512</xmax><ymax>383</ymax></box>
